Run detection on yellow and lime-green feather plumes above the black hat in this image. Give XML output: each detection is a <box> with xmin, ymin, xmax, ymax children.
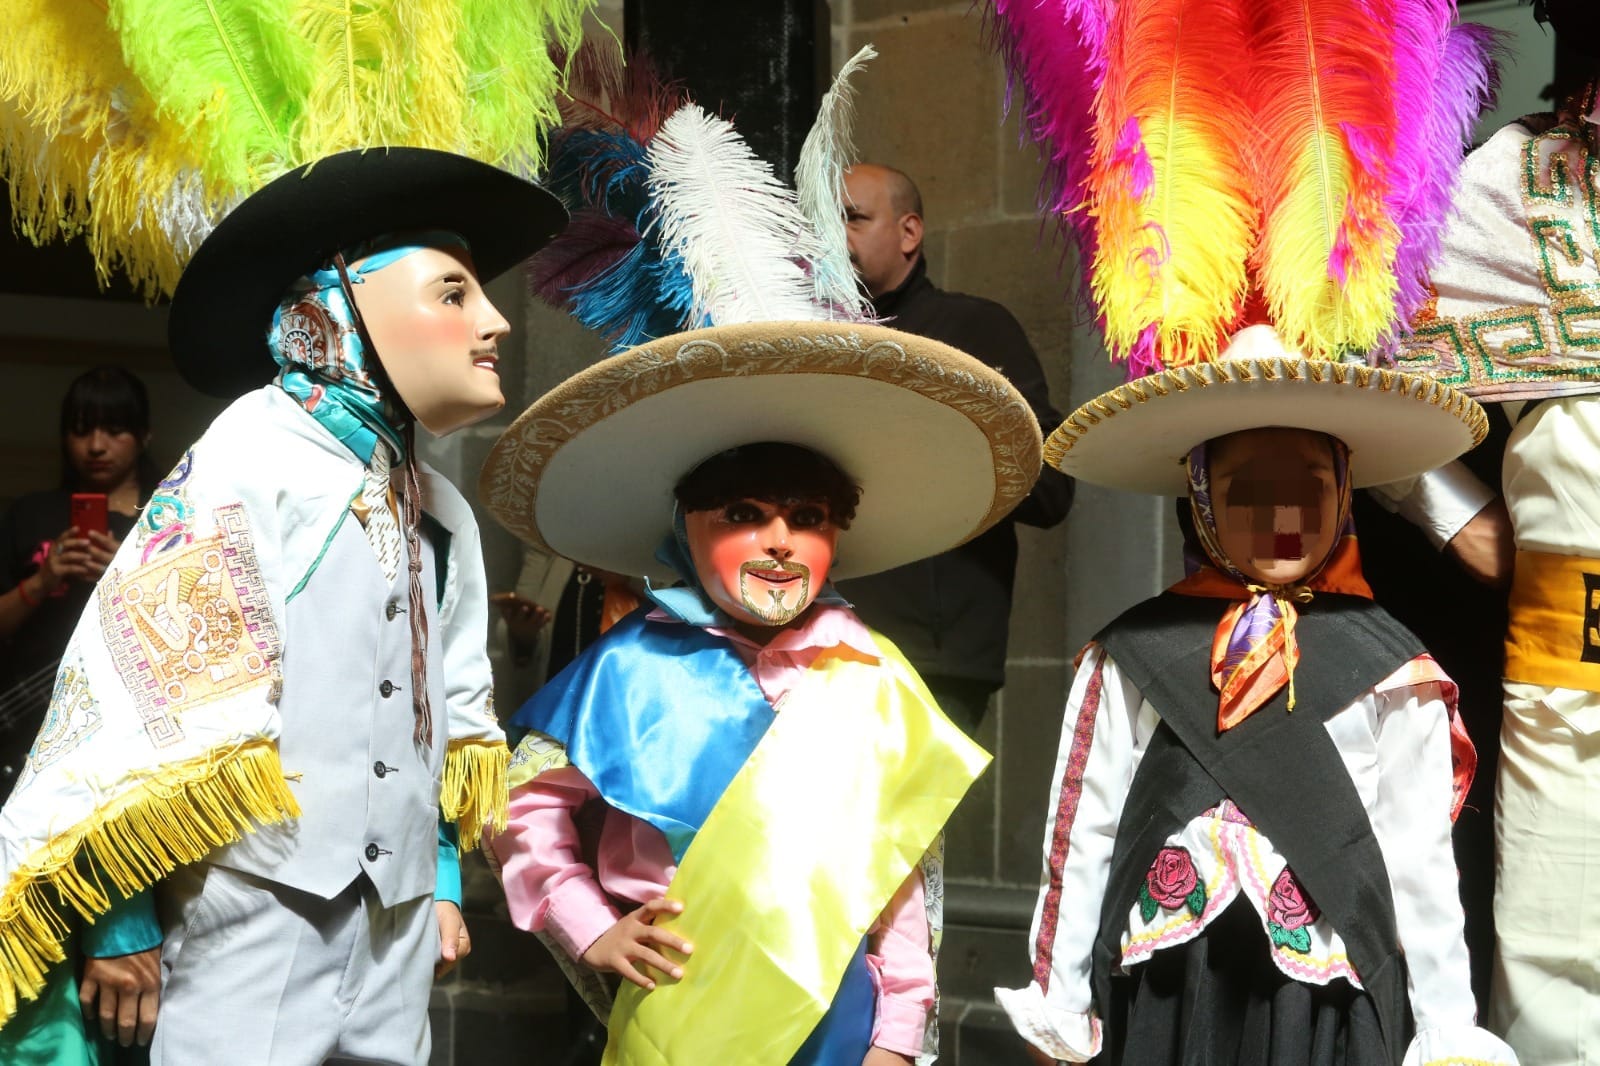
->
<box><xmin>0</xmin><ymin>0</ymin><xmax>594</xmax><ymax>298</ymax></box>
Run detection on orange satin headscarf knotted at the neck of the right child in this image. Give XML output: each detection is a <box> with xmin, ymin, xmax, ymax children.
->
<box><xmin>1173</xmin><ymin>437</ymin><xmax>1373</xmax><ymax>733</ymax></box>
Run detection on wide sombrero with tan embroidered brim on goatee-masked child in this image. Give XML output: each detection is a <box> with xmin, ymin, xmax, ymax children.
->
<box><xmin>478</xmin><ymin>322</ymin><xmax>1040</xmax><ymax>579</ymax></box>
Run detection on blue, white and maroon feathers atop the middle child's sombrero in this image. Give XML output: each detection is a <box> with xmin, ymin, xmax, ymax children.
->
<box><xmin>530</xmin><ymin>42</ymin><xmax>877</xmax><ymax>351</ymax></box>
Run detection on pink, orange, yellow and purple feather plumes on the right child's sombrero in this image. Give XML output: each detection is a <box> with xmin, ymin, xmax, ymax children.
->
<box><xmin>989</xmin><ymin>0</ymin><xmax>1494</xmax><ymax>378</ymax></box>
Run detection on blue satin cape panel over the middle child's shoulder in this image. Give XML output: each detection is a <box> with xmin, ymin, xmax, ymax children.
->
<box><xmin>512</xmin><ymin>608</ymin><xmax>773</xmax><ymax>861</ymax></box>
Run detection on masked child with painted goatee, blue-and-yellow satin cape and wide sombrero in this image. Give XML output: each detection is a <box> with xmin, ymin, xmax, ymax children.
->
<box><xmin>482</xmin><ymin>41</ymin><xmax>1038</xmax><ymax>1066</ymax></box>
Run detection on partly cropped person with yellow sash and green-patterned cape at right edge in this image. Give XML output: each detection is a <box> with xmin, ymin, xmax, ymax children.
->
<box><xmin>1390</xmin><ymin>0</ymin><xmax>1600</xmax><ymax>1066</ymax></box>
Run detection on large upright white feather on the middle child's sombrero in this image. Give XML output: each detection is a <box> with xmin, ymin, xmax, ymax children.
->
<box><xmin>650</xmin><ymin>104</ymin><xmax>826</xmax><ymax>325</ymax></box>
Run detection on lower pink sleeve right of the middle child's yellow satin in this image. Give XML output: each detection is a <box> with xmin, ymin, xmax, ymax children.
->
<box><xmin>867</xmin><ymin>866</ymin><xmax>934</xmax><ymax>1058</ymax></box>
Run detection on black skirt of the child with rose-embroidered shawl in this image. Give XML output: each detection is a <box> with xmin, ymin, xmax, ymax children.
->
<box><xmin>1094</xmin><ymin>896</ymin><xmax>1410</xmax><ymax>1066</ymax></box>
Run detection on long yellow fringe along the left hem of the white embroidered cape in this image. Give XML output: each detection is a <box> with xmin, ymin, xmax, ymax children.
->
<box><xmin>0</xmin><ymin>739</ymin><xmax>299</xmax><ymax>1026</ymax></box>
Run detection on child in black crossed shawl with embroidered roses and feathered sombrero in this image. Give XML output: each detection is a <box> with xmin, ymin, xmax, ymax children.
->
<box><xmin>995</xmin><ymin>0</ymin><xmax>1517</xmax><ymax>1066</ymax></box>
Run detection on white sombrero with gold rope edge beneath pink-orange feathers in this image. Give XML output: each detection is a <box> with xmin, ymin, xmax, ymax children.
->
<box><xmin>1045</xmin><ymin>325</ymin><xmax>1488</xmax><ymax>496</ymax></box>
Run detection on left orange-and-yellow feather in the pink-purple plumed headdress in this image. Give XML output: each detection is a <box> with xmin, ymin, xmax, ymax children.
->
<box><xmin>1090</xmin><ymin>0</ymin><xmax>1256</xmax><ymax>373</ymax></box>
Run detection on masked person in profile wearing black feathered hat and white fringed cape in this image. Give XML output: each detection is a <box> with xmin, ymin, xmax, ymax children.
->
<box><xmin>0</xmin><ymin>5</ymin><xmax>592</xmax><ymax>1066</ymax></box>
